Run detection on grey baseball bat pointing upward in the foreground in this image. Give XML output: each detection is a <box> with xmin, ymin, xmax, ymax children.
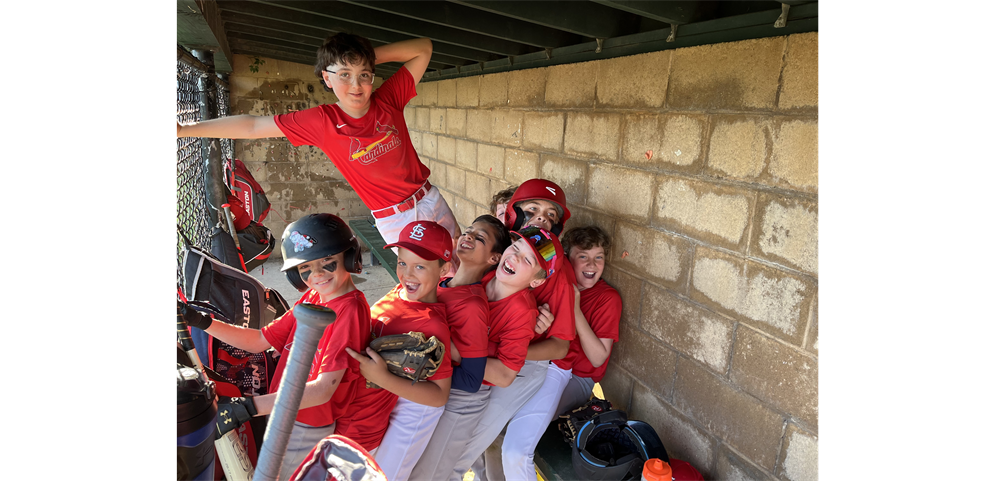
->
<box><xmin>253</xmin><ymin>303</ymin><xmax>335</xmax><ymax>481</ymax></box>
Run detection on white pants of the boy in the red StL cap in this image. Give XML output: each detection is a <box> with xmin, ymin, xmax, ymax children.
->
<box><xmin>373</xmin><ymin>397</ymin><xmax>445</xmax><ymax>481</ymax></box>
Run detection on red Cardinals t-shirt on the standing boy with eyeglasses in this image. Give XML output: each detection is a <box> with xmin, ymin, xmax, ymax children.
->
<box><xmin>275</xmin><ymin>67</ymin><xmax>430</xmax><ymax>210</ymax></box>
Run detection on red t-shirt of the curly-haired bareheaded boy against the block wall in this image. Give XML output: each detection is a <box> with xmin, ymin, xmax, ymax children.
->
<box><xmin>553</xmin><ymin>279</ymin><xmax>622</xmax><ymax>382</ymax></box>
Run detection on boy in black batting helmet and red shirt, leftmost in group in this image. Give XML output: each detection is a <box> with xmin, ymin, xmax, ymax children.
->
<box><xmin>179</xmin><ymin>214</ymin><xmax>370</xmax><ymax>481</ymax></box>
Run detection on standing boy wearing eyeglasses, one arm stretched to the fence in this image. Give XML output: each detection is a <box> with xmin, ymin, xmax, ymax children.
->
<box><xmin>176</xmin><ymin>33</ymin><xmax>460</xmax><ymax>248</ymax></box>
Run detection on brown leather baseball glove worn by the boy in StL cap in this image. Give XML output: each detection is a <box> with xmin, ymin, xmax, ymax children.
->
<box><xmin>366</xmin><ymin>331</ymin><xmax>446</xmax><ymax>389</ymax></box>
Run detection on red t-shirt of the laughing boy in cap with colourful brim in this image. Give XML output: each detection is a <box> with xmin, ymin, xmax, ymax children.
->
<box><xmin>481</xmin><ymin>271</ymin><xmax>539</xmax><ymax>386</ymax></box>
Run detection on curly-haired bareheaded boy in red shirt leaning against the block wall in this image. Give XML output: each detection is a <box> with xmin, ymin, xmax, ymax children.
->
<box><xmin>553</xmin><ymin>226</ymin><xmax>622</xmax><ymax>415</ymax></box>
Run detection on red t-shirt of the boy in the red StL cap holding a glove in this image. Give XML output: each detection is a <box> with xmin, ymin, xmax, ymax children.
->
<box><xmin>335</xmin><ymin>284</ymin><xmax>453</xmax><ymax>451</ymax></box>
